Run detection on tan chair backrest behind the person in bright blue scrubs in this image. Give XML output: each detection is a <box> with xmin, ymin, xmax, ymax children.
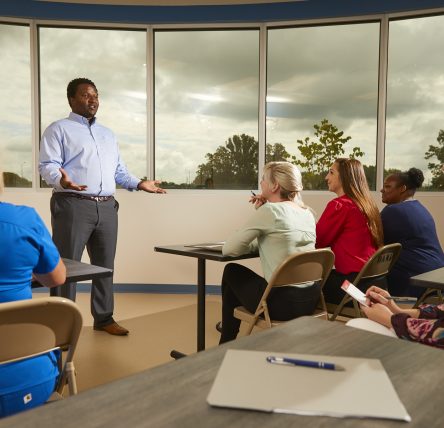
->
<box><xmin>0</xmin><ymin>297</ymin><xmax>83</xmax><ymax>364</ymax></box>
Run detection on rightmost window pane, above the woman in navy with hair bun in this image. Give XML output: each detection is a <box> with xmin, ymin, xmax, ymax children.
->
<box><xmin>385</xmin><ymin>16</ymin><xmax>444</xmax><ymax>190</ymax></box>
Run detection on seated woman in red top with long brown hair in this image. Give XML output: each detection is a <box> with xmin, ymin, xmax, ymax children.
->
<box><xmin>316</xmin><ymin>158</ymin><xmax>384</xmax><ymax>304</ymax></box>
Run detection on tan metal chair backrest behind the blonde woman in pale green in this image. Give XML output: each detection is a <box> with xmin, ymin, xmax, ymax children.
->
<box><xmin>261</xmin><ymin>248</ymin><xmax>335</xmax><ymax>301</ymax></box>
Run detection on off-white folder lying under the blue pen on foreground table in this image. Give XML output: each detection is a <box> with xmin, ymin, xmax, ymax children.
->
<box><xmin>207</xmin><ymin>349</ymin><xmax>411</xmax><ymax>422</ymax></box>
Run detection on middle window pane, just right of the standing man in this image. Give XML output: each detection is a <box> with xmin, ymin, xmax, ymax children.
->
<box><xmin>155</xmin><ymin>30</ymin><xmax>259</xmax><ymax>189</ymax></box>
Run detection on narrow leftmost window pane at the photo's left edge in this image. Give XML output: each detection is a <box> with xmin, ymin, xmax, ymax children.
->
<box><xmin>0</xmin><ymin>24</ymin><xmax>33</xmax><ymax>187</ymax></box>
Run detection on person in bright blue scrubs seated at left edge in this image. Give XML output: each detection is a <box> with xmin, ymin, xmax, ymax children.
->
<box><xmin>0</xmin><ymin>171</ymin><xmax>66</xmax><ymax>417</ymax></box>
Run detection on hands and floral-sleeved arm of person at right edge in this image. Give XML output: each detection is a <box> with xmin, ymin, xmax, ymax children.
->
<box><xmin>361</xmin><ymin>286</ymin><xmax>444</xmax><ymax>348</ymax></box>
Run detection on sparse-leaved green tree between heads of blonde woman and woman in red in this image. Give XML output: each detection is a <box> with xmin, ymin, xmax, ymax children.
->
<box><xmin>291</xmin><ymin>119</ymin><xmax>364</xmax><ymax>189</ymax></box>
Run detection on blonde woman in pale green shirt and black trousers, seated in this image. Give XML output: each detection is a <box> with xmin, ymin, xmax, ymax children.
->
<box><xmin>219</xmin><ymin>162</ymin><xmax>321</xmax><ymax>343</ymax></box>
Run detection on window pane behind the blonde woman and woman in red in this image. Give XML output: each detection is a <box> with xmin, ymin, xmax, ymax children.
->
<box><xmin>267</xmin><ymin>23</ymin><xmax>379</xmax><ymax>189</ymax></box>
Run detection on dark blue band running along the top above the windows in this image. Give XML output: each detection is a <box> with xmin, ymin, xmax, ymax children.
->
<box><xmin>0</xmin><ymin>0</ymin><xmax>444</xmax><ymax>24</ymax></box>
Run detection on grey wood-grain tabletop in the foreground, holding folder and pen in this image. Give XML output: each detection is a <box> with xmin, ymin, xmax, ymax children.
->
<box><xmin>0</xmin><ymin>317</ymin><xmax>444</xmax><ymax>428</ymax></box>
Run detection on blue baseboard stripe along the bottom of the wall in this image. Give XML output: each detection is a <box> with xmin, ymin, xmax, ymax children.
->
<box><xmin>32</xmin><ymin>282</ymin><xmax>221</xmax><ymax>295</ymax></box>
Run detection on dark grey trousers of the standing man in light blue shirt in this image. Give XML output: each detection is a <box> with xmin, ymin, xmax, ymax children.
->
<box><xmin>50</xmin><ymin>193</ymin><xmax>119</xmax><ymax>327</ymax></box>
